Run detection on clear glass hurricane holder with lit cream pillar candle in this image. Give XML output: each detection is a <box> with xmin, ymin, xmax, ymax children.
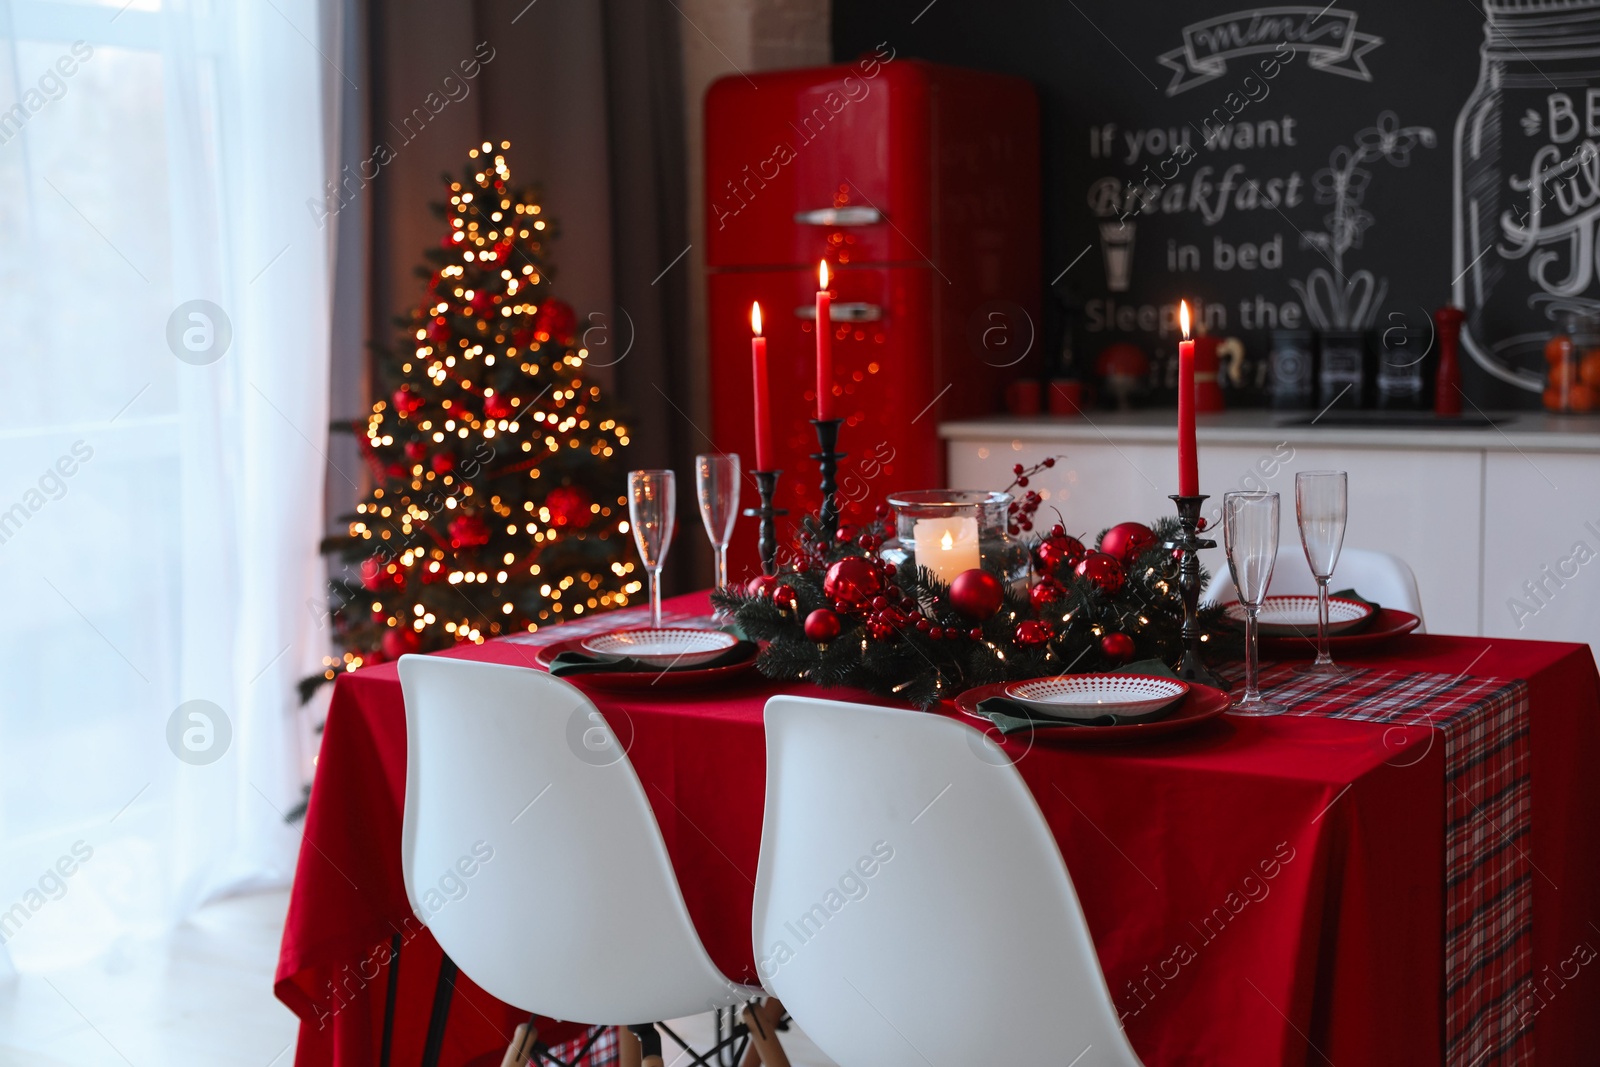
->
<box><xmin>878</xmin><ymin>490</ymin><xmax>1027</xmax><ymax>589</ymax></box>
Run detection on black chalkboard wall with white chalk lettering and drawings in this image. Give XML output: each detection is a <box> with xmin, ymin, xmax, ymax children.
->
<box><xmin>834</xmin><ymin>0</ymin><xmax>1600</xmax><ymax>408</ymax></box>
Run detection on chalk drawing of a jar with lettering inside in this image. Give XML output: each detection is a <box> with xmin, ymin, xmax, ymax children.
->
<box><xmin>1453</xmin><ymin>0</ymin><xmax>1600</xmax><ymax>394</ymax></box>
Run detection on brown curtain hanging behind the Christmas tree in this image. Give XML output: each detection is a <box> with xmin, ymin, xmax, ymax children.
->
<box><xmin>330</xmin><ymin>0</ymin><xmax>709</xmax><ymax>589</ymax></box>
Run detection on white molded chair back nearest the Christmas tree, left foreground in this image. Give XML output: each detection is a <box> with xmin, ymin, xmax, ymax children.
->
<box><xmin>400</xmin><ymin>656</ymin><xmax>746</xmax><ymax>1025</ymax></box>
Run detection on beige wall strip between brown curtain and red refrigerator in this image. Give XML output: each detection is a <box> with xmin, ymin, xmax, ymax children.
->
<box><xmin>678</xmin><ymin>0</ymin><xmax>830</xmax><ymax>441</ymax></box>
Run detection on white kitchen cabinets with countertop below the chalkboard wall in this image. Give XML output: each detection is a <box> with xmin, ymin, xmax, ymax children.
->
<box><xmin>941</xmin><ymin>411</ymin><xmax>1600</xmax><ymax>649</ymax></box>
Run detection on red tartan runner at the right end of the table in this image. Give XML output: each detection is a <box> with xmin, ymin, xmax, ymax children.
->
<box><xmin>1230</xmin><ymin>664</ymin><xmax>1533</xmax><ymax>1067</ymax></box>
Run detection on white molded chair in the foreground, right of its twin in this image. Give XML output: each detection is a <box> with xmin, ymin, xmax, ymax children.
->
<box><xmin>752</xmin><ymin>696</ymin><xmax>1139</xmax><ymax>1067</ymax></box>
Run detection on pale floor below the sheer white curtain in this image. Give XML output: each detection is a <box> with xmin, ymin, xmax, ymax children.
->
<box><xmin>0</xmin><ymin>893</ymin><xmax>834</xmax><ymax>1067</ymax></box>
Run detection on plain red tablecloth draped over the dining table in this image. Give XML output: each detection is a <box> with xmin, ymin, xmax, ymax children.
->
<box><xmin>277</xmin><ymin>595</ymin><xmax>1600</xmax><ymax>1067</ymax></box>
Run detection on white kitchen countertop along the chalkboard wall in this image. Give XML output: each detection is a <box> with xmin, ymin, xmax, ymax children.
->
<box><xmin>939</xmin><ymin>408</ymin><xmax>1600</xmax><ymax>454</ymax></box>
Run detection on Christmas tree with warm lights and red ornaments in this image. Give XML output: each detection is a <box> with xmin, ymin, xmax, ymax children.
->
<box><xmin>307</xmin><ymin>141</ymin><xmax>640</xmax><ymax>685</ymax></box>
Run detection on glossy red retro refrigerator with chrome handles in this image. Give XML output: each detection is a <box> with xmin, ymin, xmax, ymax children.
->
<box><xmin>706</xmin><ymin>50</ymin><xmax>1042</xmax><ymax>577</ymax></box>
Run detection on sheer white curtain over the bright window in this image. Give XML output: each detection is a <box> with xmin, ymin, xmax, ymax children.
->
<box><xmin>0</xmin><ymin>0</ymin><xmax>337</xmax><ymax>971</ymax></box>
